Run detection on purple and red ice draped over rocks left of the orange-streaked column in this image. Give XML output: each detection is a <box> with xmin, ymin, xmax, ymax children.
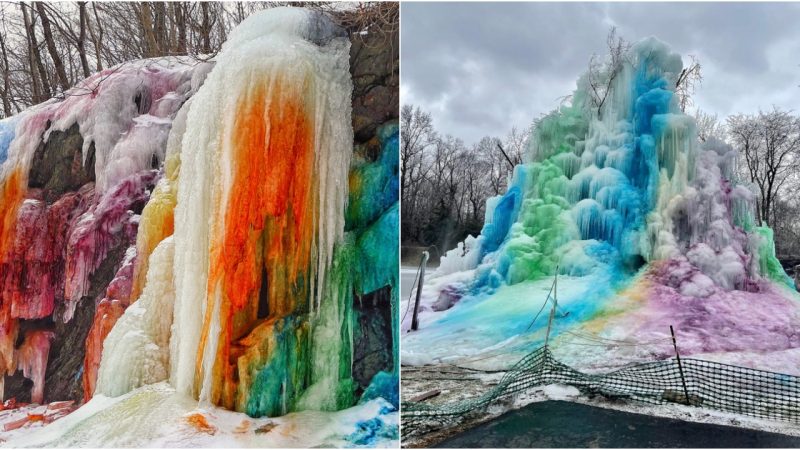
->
<box><xmin>0</xmin><ymin>59</ymin><xmax>198</xmax><ymax>402</ymax></box>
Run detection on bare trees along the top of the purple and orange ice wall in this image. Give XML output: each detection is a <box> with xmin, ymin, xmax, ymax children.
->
<box><xmin>0</xmin><ymin>1</ymin><xmax>399</xmax><ymax>116</ymax></box>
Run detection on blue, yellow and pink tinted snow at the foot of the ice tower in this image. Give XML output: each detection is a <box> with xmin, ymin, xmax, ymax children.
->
<box><xmin>401</xmin><ymin>268</ymin><xmax>800</xmax><ymax>375</ymax></box>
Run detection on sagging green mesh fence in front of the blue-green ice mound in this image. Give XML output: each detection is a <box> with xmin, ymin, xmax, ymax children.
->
<box><xmin>401</xmin><ymin>347</ymin><xmax>800</xmax><ymax>436</ymax></box>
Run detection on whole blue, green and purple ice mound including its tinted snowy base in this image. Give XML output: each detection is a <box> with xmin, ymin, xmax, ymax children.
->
<box><xmin>403</xmin><ymin>38</ymin><xmax>800</xmax><ymax>372</ymax></box>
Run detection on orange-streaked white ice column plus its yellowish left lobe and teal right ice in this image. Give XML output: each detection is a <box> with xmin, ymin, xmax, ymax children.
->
<box><xmin>95</xmin><ymin>8</ymin><xmax>397</xmax><ymax>416</ymax></box>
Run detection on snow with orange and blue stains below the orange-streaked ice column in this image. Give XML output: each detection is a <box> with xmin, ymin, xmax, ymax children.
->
<box><xmin>0</xmin><ymin>383</ymin><xmax>399</xmax><ymax>448</ymax></box>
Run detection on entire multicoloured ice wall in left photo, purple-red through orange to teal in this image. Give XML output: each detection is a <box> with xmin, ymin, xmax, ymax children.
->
<box><xmin>0</xmin><ymin>8</ymin><xmax>399</xmax><ymax>440</ymax></box>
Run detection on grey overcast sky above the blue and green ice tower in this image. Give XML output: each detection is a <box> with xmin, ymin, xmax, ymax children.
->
<box><xmin>400</xmin><ymin>2</ymin><xmax>800</xmax><ymax>144</ymax></box>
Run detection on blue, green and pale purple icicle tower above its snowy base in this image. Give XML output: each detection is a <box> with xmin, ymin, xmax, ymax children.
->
<box><xmin>441</xmin><ymin>39</ymin><xmax>780</xmax><ymax>289</ymax></box>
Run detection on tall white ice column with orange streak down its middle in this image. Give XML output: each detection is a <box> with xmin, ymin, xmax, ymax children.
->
<box><xmin>172</xmin><ymin>8</ymin><xmax>353</xmax><ymax>414</ymax></box>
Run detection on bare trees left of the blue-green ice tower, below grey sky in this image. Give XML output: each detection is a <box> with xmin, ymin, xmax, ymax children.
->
<box><xmin>400</xmin><ymin>104</ymin><xmax>527</xmax><ymax>248</ymax></box>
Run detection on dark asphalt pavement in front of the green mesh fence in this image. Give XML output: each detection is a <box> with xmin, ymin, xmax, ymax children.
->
<box><xmin>436</xmin><ymin>401</ymin><xmax>800</xmax><ymax>448</ymax></box>
